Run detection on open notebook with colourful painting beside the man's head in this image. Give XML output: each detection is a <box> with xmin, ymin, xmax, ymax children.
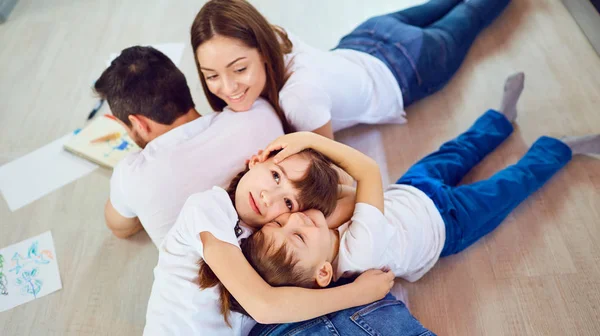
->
<box><xmin>64</xmin><ymin>115</ymin><xmax>140</xmax><ymax>168</ymax></box>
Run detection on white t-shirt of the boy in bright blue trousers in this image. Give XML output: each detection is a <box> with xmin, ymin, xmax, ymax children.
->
<box><xmin>334</xmin><ymin>184</ymin><xmax>446</xmax><ymax>282</ymax></box>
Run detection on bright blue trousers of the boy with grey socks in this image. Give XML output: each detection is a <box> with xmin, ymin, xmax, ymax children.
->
<box><xmin>396</xmin><ymin>110</ymin><xmax>572</xmax><ymax>257</ymax></box>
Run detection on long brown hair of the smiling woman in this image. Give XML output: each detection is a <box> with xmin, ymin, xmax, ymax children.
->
<box><xmin>190</xmin><ymin>0</ymin><xmax>294</xmax><ymax>133</ymax></box>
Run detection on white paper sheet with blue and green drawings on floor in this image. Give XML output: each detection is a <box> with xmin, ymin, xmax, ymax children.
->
<box><xmin>0</xmin><ymin>231</ymin><xmax>62</xmax><ymax>312</ymax></box>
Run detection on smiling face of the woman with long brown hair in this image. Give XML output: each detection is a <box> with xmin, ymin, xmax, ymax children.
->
<box><xmin>196</xmin><ymin>35</ymin><xmax>267</xmax><ymax>112</ymax></box>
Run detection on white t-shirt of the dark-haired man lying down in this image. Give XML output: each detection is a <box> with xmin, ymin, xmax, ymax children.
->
<box><xmin>110</xmin><ymin>99</ymin><xmax>283</xmax><ymax>246</ymax></box>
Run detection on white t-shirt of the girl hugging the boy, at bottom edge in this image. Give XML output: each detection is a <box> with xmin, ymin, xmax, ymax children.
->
<box><xmin>144</xmin><ymin>187</ymin><xmax>256</xmax><ymax>336</ymax></box>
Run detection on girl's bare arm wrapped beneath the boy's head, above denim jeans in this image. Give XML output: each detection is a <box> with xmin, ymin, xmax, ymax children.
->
<box><xmin>200</xmin><ymin>231</ymin><xmax>394</xmax><ymax>324</ymax></box>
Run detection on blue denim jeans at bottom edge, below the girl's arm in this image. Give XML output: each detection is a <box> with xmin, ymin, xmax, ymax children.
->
<box><xmin>250</xmin><ymin>294</ymin><xmax>435</xmax><ymax>336</ymax></box>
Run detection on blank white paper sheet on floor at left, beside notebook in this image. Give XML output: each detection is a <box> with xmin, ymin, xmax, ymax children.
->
<box><xmin>0</xmin><ymin>133</ymin><xmax>98</xmax><ymax>211</ymax></box>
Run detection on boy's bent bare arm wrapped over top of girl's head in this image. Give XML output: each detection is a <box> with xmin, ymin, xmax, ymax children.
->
<box><xmin>260</xmin><ymin>132</ymin><xmax>383</xmax><ymax>213</ymax></box>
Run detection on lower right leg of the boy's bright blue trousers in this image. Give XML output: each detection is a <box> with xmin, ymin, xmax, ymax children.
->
<box><xmin>441</xmin><ymin>137</ymin><xmax>572</xmax><ymax>257</ymax></box>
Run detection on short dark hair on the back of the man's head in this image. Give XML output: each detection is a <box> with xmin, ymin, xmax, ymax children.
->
<box><xmin>94</xmin><ymin>46</ymin><xmax>194</xmax><ymax>126</ymax></box>
